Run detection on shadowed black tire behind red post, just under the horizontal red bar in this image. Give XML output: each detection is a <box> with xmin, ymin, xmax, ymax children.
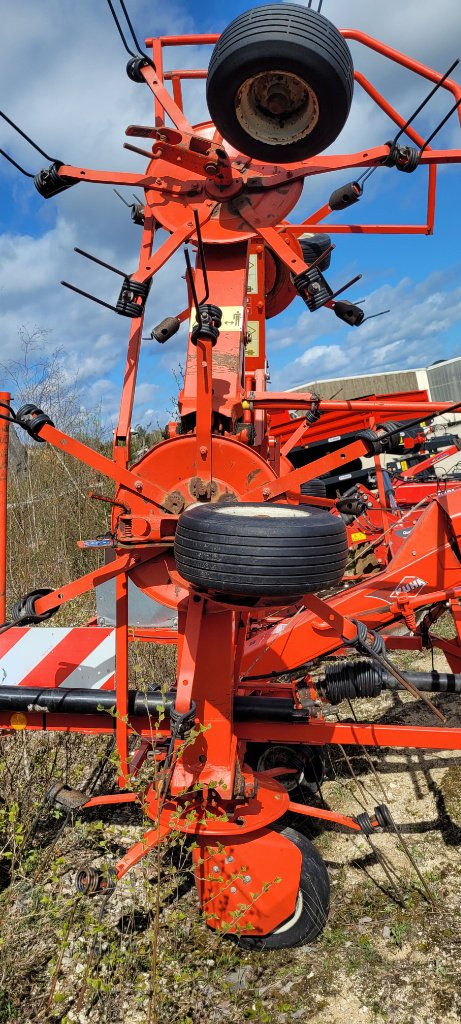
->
<box><xmin>245</xmin><ymin>743</ymin><xmax>325</xmax><ymax>797</ymax></box>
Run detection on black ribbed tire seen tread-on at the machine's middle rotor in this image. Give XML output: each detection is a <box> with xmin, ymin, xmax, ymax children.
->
<box><xmin>174</xmin><ymin>502</ymin><xmax>347</xmax><ymax>598</ymax></box>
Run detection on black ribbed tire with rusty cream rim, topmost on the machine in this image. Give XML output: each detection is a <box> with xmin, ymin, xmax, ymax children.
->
<box><xmin>207</xmin><ymin>3</ymin><xmax>353</xmax><ymax>164</ymax></box>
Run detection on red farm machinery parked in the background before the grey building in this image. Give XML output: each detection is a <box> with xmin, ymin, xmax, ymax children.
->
<box><xmin>271</xmin><ymin>403</ymin><xmax>461</xmax><ymax>582</ymax></box>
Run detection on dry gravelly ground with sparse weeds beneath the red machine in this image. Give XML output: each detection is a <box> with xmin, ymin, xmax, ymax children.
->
<box><xmin>0</xmin><ymin>654</ymin><xmax>461</xmax><ymax>1024</ymax></box>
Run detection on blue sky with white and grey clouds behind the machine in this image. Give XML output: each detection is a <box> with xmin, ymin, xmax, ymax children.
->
<box><xmin>0</xmin><ymin>0</ymin><xmax>461</xmax><ymax>425</ymax></box>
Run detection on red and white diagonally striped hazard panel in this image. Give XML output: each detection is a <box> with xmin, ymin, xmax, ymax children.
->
<box><xmin>0</xmin><ymin>626</ymin><xmax>115</xmax><ymax>690</ymax></box>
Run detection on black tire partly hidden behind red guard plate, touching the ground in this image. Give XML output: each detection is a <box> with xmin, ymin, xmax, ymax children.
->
<box><xmin>237</xmin><ymin>828</ymin><xmax>330</xmax><ymax>950</ymax></box>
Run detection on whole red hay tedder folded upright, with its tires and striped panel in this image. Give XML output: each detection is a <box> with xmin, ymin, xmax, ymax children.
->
<box><xmin>0</xmin><ymin>0</ymin><xmax>461</xmax><ymax>949</ymax></box>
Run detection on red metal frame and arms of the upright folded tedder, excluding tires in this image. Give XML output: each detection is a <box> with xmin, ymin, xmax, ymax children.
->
<box><xmin>0</xmin><ymin>19</ymin><xmax>461</xmax><ymax>935</ymax></box>
